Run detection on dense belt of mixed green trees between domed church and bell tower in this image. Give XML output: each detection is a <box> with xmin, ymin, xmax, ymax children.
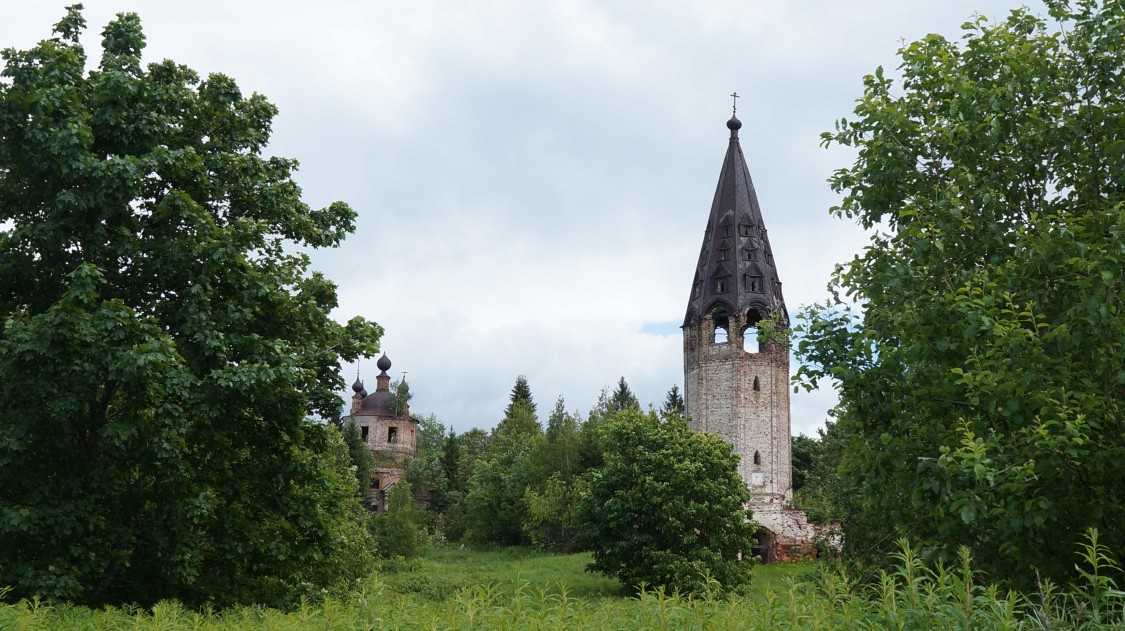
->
<box><xmin>335</xmin><ymin>376</ymin><xmax>755</xmax><ymax>594</ymax></box>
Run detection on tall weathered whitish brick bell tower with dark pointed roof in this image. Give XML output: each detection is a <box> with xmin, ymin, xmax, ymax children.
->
<box><xmin>683</xmin><ymin>110</ymin><xmax>792</xmax><ymax>506</ymax></box>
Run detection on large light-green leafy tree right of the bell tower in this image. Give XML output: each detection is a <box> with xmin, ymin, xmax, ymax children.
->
<box><xmin>800</xmin><ymin>0</ymin><xmax>1125</xmax><ymax>586</ymax></box>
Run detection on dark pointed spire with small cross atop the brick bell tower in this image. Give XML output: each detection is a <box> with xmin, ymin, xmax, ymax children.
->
<box><xmin>684</xmin><ymin>105</ymin><xmax>789</xmax><ymax>326</ymax></box>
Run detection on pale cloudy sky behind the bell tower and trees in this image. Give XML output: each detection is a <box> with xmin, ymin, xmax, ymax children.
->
<box><xmin>0</xmin><ymin>0</ymin><xmax>1043</xmax><ymax>433</ymax></box>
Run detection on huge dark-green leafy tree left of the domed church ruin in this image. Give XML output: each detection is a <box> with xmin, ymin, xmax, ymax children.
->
<box><xmin>0</xmin><ymin>6</ymin><xmax>381</xmax><ymax>605</ymax></box>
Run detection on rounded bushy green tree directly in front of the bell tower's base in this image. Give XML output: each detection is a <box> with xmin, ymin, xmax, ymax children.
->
<box><xmin>578</xmin><ymin>411</ymin><xmax>756</xmax><ymax>593</ymax></box>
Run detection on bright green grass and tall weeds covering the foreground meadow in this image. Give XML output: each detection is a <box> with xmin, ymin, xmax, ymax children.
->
<box><xmin>0</xmin><ymin>532</ymin><xmax>1125</xmax><ymax>631</ymax></box>
